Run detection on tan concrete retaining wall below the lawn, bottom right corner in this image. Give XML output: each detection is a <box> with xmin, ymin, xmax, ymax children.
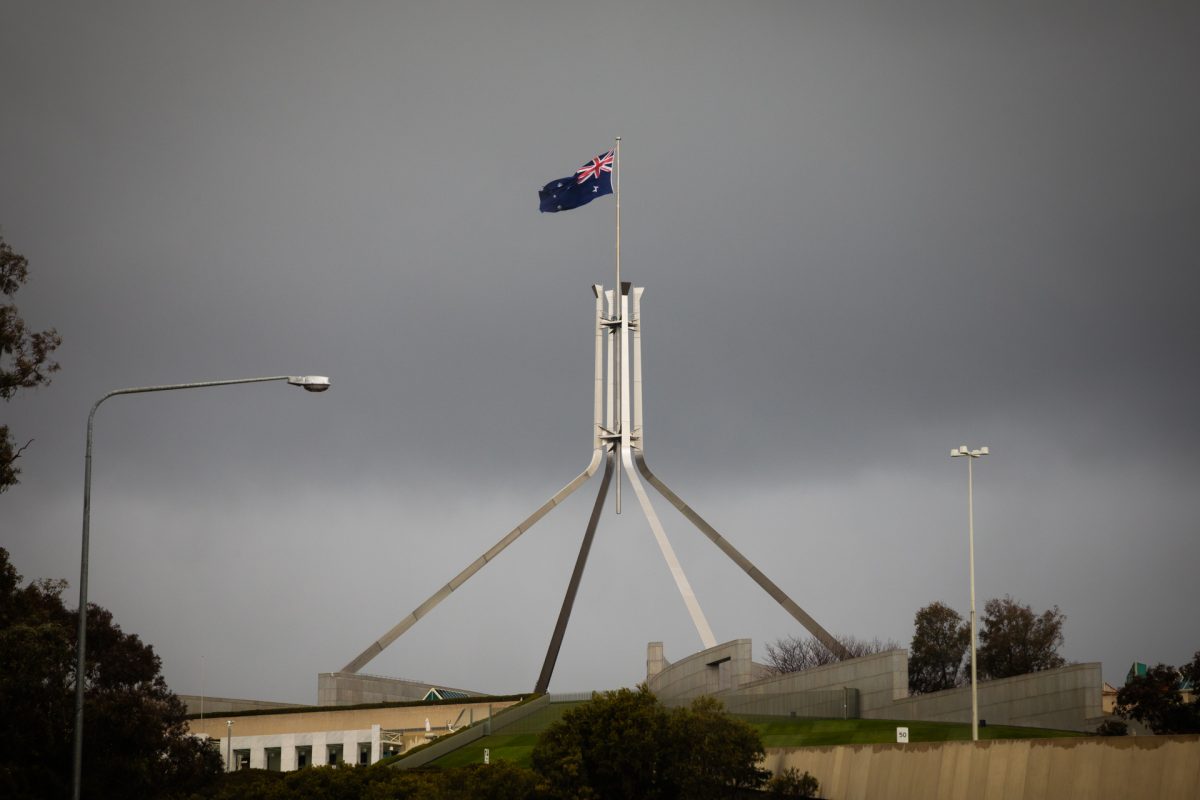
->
<box><xmin>763</xmin><ymin>735</ymin><xmax>1200</xmax><ymax>800</ymax></box>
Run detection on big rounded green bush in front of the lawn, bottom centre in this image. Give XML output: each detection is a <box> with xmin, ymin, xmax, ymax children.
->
<box><xmin>533</xmin><ymin>685</ymin><xmax>768</xmax><ymax>800</ymax></box>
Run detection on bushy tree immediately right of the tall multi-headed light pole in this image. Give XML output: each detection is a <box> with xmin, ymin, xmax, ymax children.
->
<box><xmin>978</xmin><ymin>595</ymin><xmax>1067</xmax><ymax>679</ymax></box>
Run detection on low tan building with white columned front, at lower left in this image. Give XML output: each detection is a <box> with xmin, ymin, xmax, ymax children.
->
<box><xmin>188</xmin><ymin>687</ymin><xmax>520</xmax><ymax>771</ymax></box>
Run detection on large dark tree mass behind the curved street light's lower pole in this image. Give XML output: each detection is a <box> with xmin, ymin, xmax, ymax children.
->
<box><xmin>0</xmin><ymin>548</ymin><xmax>221</xmax><ymax>799</ymax></box>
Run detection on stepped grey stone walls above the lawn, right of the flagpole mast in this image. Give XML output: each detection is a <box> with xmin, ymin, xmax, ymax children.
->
<box><xmin>646</xmin><ymin>639</ymin><xmax>1104</xmax><ymax>732</ymax></box>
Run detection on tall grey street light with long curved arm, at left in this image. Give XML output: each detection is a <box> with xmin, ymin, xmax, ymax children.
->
<box><xmin>71</xmin><ymin>375</ymin><xmax>329</xmax><ymax>800</ymax></box>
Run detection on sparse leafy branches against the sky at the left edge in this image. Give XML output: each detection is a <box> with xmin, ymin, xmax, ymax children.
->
<box><xmin>0</xmin><ymin>236</ymin><xmax>62</xmax><ymax>493</ymax></box>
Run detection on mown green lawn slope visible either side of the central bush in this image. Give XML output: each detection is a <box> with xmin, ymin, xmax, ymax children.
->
<box><xmin>417</xmin><ymin>714</ymin><xmax>1085</xmax><ymax>768</ymax></box>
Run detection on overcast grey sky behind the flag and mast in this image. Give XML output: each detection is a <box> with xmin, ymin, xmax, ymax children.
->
<box><xmin>0</xmin><ymin>0</ymin><xmax>1200</xmax><ymax>703</ymax></box>
